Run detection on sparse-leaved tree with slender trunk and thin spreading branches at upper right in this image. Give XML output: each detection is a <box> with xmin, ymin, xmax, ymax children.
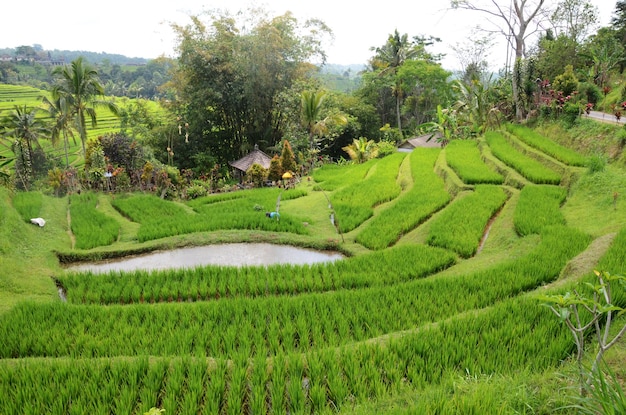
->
<box><xmin>450</xmin><ymin>0</ymin><xmax>546</xmax><ymax>119</ymax></box>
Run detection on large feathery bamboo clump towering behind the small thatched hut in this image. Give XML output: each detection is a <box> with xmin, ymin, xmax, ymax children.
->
<box><xmin>172</xmin><ymin>9</ymin><xmax>330</xmax><ymax>167</ymax></box>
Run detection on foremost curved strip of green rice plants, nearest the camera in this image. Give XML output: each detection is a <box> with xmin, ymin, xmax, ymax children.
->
<box><xmin>0</xmin><ymin>299</ymin><xmax>571</xmax><ymax>414</ymax></box>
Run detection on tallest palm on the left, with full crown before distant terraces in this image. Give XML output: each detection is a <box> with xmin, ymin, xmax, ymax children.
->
<box><xmin>51</xmin><ymin>57</ymin><xmax>118</xmax><ymax>156</ymax></box>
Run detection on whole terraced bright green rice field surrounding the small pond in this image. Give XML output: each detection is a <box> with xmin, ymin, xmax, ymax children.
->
<box><xmin>0</xmin><ymin>99</ymin><xmax>626</xmax><ymax>415</ymax></box>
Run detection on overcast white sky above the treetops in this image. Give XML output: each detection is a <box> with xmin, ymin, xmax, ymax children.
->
<box><xmin>0</xmin><ymin>0</ymin><xmax>616</xmax><ymax>69</ymax></box>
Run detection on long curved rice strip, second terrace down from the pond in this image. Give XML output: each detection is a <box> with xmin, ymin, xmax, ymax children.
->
<box><xmin>0</xmin><ymin>226</ymin><xmax>589</xmax><ymax>358</ymax></box>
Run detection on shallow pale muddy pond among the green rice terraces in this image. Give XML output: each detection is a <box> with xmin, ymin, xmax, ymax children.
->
<box><xmin>67</xmin><ymin>243</ymin><xmax>344</xmax><ymax>273</ymax></box>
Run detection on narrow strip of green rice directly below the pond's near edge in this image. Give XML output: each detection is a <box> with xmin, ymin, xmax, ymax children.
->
<box><xmin>58</xmin><ymin>245</ymin><xmax>455</xmax><ymax>304</ymax></box>
